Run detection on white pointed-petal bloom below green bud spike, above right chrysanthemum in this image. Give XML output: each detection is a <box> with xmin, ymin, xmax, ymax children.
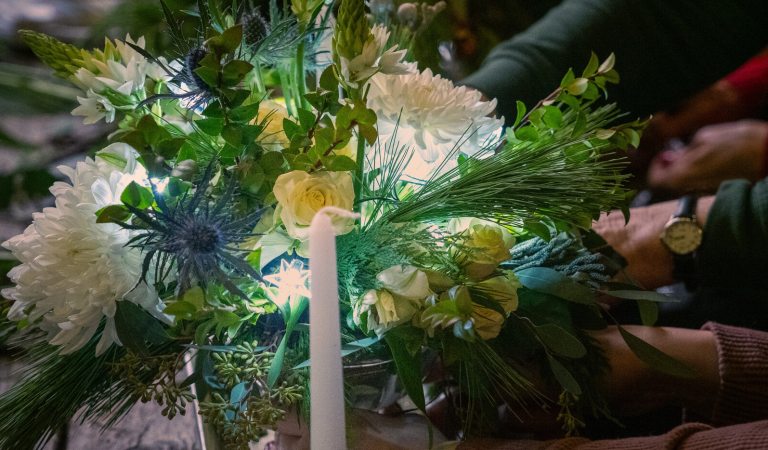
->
<box><xmin>341</xmin><ymin>24</ymin><xmax>413</xmax><ymax>82</ymax></box>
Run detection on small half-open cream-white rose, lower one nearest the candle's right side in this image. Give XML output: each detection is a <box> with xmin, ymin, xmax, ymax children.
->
<box><xmin>353</xmin><ymin>289</ymin><xmax>418</xmax><ymax>336</ymax></box>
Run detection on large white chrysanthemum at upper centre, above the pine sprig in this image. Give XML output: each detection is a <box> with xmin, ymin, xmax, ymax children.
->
<box><xmin>368</xmin><ymin>69</ymin><xmax>504</xmax><ymax>180</ymax></box>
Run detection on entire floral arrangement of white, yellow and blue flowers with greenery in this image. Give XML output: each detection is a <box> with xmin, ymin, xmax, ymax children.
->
<box><xmin>0</xmin><ymin>0</ymin><xmax>685</xmax><ymax>448</ymax></box>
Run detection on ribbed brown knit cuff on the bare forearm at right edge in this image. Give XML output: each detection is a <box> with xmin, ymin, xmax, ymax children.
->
<box><xmin>702</xmin><ymin>322</ymin><xmax>768</xmax><ymax>426</ymax></box>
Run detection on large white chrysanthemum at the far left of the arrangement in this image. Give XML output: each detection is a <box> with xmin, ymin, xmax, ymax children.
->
<box><xmin>2</xmin><ymin>143</ymin><xmax>160</xmax><ymax>354</ymax></box>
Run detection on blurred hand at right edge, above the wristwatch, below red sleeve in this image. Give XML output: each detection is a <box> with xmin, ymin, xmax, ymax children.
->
<box><xmin>648</xmin><ymin>120</ymin><xmax>768</xmax><ymax>193</ymax></box>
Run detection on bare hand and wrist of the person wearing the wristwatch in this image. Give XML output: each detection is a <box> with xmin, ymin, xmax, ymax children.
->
<box><xmin>593</xmin><ymin>197</ymin><xmax>714</xmax><ymax>289</ymax></box>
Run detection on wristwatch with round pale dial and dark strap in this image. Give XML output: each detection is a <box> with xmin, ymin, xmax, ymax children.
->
<box><xmin>661</xmin><ymin>195</ymin><xmax>703</xmax><ymax>289</ymax></box>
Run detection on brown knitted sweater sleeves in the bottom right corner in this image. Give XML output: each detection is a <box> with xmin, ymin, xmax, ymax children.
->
<box><xmin>458</xmin><ymin>322</ymin><xmax>768</xmax><ymax>450</ymax></box>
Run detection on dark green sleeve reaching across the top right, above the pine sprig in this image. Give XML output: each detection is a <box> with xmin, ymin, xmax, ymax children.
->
<box><xmin>462</xmin><ymin>0</ymin><xmax>768</xmax><ymax>120</ymax></box>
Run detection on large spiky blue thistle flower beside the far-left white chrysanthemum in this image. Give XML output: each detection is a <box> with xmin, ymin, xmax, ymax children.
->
<box><xmin>122</xmin><ymin>162</ymin><xmax>263</xmax><ymax>299</ymax></box>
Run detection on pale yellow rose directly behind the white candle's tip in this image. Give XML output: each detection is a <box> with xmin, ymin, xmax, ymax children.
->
<box><xmin>272</xmin><ymin>170</ymin><xmax>355</xmax><ymax>241</ymax></box>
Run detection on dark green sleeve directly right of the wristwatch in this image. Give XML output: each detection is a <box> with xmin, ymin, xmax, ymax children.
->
<box><xmin>697</xmin><ymin>178</ymin><xmax>768</xmax><ymax>293</ymax></box>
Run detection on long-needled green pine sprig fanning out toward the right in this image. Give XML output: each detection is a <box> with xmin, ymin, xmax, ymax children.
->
<box><xmin>386</xmin><ymin>105</ymin><xmax>626</xmax><ymax>229</ymax></box>
